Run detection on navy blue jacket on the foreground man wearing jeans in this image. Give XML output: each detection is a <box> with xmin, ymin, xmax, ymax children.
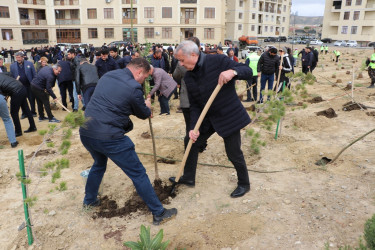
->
<box><xmin>79</xmin><ymin>68</ymin><xmax>151</xmax><ymax>140</ymax></box>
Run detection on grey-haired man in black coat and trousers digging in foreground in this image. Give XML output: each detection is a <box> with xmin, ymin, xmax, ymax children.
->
<box><xmin>170</xmin><ymin>41</ymin><xmax>252</xmax><ymax>198</ymax></box>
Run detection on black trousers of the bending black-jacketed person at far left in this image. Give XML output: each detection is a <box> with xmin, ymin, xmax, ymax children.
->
<box><xmin>10</xmin><ymin>88</ymin><xmax>36</xmax><ymax>134</ymax></box>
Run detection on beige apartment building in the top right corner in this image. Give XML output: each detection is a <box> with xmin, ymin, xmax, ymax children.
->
<box><xmin>322</xmin><ymin>0</ymin><xmax>375</xmax><ymax>45</ymax></box>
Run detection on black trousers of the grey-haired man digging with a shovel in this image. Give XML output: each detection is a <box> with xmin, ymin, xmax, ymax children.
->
<box><xmin>184</xmin><ymin>126</ymin><xmax>250</xmax><ymax>186</ymax></box>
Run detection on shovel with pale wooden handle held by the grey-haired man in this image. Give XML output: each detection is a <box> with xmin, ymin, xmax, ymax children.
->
<box><xmin>170</xmin><ymin>84</ymin><xmax>222</xmax><ymax>195</ymax></box>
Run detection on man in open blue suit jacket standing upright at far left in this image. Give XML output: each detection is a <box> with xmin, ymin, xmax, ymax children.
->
<box><xmin>10</xmin><ymin>52</ymin><xmax>36</xmax><ymax>119</ymax></box>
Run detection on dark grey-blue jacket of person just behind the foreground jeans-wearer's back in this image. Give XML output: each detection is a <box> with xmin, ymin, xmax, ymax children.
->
<box><xmin>76</xmin><ymin>63</ymin><xmax>99</xmax><ymax>95</ymax></box>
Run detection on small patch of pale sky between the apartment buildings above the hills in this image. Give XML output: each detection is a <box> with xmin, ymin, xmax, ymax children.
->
<box><xmin>292</xmin><ymin>0</ymin><xmax>325</xmax><ymax>16</ymax></box>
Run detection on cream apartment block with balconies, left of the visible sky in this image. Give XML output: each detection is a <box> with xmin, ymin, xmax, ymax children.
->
<box><xmin>225</xmin><ymin>0</ymin><xmax>292</xmax><ymax>40</ymax></box>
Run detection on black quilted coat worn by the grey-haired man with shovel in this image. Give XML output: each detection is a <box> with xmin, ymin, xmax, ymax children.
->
<box><xmin>184</xmin><ymin>53</ymin><xmax>252</xmax><ymax>137</ymax></box>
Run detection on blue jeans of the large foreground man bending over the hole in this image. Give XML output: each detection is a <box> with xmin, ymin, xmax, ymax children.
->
<box><xmin>81</xmin><ymin>135</ymin><xmax>164</xmax><ymax>215</ymax></box>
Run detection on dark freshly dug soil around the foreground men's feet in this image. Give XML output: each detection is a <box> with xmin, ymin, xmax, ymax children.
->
<box><xmin>93</xmin><ymin>180</ymin><xmax>173</xmax><ymax>219</ymax></box>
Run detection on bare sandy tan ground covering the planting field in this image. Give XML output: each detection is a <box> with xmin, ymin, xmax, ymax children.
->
<box><xmin>0</xmin><ymin>46</ymin><xmax>375</xmax><ymax>250</ymax></box>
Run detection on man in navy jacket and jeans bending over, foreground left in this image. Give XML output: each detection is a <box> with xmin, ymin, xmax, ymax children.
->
<box><xmin>79</xmin><ymin>58</ymin><xmax>177</xmax><ymax>225</ymax></box>
